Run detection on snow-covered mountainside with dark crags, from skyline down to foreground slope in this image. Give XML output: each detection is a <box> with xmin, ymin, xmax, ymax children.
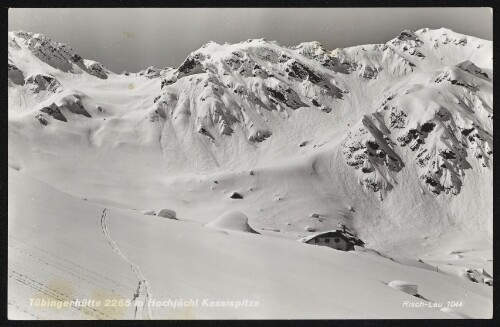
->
<box><xmin>8</xmin><ymin>28</ymin><xmax>493</xmax><ymax>320</ymax></box>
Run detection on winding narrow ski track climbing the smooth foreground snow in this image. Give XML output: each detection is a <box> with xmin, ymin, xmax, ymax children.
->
<box><xmin>101</xmin><ymin>208</ymin><xmax>153</xmax><ymax>319</ymax></box>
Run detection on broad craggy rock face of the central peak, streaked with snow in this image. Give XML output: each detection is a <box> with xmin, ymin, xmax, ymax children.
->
<box><xmin>150</xmin><ymin>40</ymin><xmax>352</xmax><ymax>143</ymax></box>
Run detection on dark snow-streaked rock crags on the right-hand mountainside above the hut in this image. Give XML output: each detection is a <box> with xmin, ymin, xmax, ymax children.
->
<box><xmin>342</xmin><ymin>56</ymin><xmax>493</xmax><ymax>199</ymax></box>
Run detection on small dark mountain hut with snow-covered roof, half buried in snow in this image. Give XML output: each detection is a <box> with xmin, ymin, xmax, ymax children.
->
<box><xmin>299</xmin><ymin>229</ymin><xmax>365</xmax><ymax>251</ymax></box>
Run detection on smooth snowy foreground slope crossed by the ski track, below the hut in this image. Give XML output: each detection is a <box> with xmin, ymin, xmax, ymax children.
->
<box><xmin>8</xmin><ymin>170</ymin><xmax>492</xmax><ymax>319</ymax></box>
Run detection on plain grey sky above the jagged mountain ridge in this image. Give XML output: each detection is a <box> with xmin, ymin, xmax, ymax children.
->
<box><xmin>8</xmin><ymin>8</ymin><xmax>493</xmax><ymax>73</ymax></box>
